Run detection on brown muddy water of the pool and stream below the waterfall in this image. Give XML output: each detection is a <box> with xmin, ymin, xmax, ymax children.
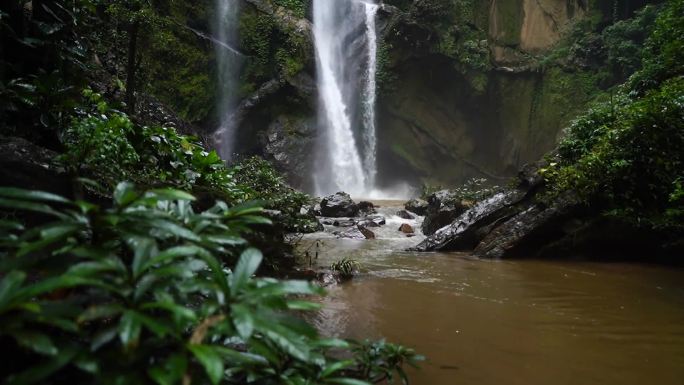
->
<box><xmin>299</xmin><ymin>202</ymin><xmax>684</xmax><ymax>385</ymax></box>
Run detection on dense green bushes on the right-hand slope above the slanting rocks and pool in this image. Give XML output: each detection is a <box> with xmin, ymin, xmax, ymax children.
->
<box><xmin>541</xmin><ymin>0</ymin><xmax>684</xmax><ymax>227</ymax></box>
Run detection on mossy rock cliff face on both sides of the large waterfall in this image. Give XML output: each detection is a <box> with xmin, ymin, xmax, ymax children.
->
<box><xmin>162</xmin><ymin>0</ymin><xmax>645</xmax><ymax>189</ymax></box>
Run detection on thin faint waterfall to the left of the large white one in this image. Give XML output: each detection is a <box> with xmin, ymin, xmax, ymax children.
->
<box><xmin>213</xmin><ymin>0</ymin><xmax>243</xmax><ymax>160</ymax></box>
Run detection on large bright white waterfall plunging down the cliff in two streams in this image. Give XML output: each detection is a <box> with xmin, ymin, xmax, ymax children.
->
<box><xmin>313</xmin><ymin>0</ymin><xmax>378</xmax><ymax>196</ymax></box>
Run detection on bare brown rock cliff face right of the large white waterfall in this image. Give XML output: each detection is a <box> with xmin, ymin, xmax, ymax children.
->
<box><xmin>379</xmin><ymin>0</ymin><xmax>596</xmax><ymax>185</ymax></box>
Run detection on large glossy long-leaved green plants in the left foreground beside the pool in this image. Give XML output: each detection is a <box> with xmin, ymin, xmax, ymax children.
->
<box><xmin>0</xmin><ymin>183</ymin><xmax>419</xmax><ymax>384</ymax></box>
